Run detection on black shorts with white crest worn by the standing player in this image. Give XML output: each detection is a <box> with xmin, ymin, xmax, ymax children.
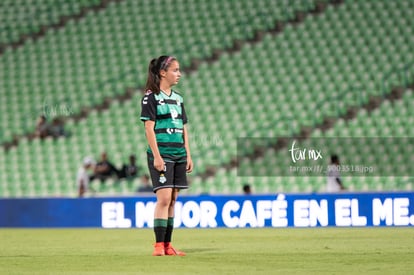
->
<box><xmin>148</xmin><ymin>159</ymin><xmax>188</xmax><ymax>192</ymax></box>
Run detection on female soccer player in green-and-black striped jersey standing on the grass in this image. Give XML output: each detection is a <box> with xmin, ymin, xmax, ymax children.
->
<box><xmin>141</xmin><ymin>56</ymin><xmax>193</xmax><ymax>256</ymax></box>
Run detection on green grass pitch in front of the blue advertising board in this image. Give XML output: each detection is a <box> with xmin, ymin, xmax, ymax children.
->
<box><xmin>0</xmin><ymin>227</ymin><xmax>414</xmax><ymax>274</ymax></box>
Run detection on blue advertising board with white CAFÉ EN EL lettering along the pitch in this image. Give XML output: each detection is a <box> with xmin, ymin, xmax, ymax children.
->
<box><xmin>0</xmin><ymin>192</ymin><xmax>414</xmax><ymax>228</ymax></box>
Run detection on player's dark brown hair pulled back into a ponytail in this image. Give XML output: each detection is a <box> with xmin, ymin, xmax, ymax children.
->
<box><xmin>145</xmin><ymin>55</ymin><xmax>176</xmax><ymax>94</ymax></box>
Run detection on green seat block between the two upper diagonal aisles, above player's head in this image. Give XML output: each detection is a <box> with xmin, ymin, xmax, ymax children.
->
<box><xmin>0</xmin><ymin>0</ymin><xmax>326</xmax><ymax>147</ymax></box>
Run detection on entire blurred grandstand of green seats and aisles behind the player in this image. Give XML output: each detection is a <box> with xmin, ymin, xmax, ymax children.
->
<box><xmin>0</xmin><ymin>0</ymin><xmax>414</xmax><ymax>198</ymax></box>
